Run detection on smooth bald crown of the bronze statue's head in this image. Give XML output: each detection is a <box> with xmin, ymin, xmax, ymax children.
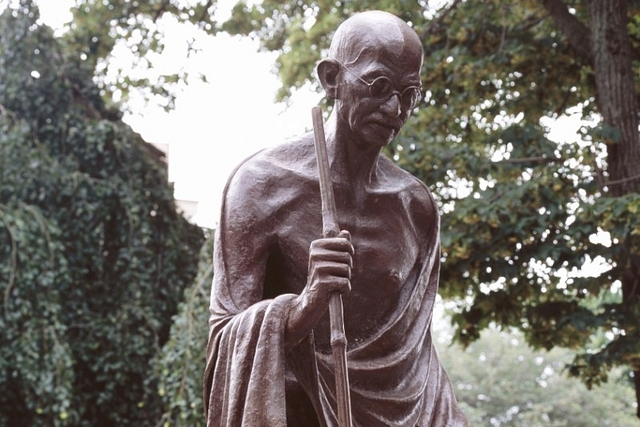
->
<box><xmin>329</xmin><ymin>11</ymin><xmax>422</xmax><ymax>64</ymax></box>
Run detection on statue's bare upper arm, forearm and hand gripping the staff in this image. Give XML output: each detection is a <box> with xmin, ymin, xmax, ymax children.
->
<box><xmin>210</xmin><ymin>162</ymin><xmax>353</xmax><ymax>349</ymax></box>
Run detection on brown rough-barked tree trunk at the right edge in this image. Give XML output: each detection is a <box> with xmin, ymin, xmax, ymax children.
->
<box><xmin>588</xmin><ymin>0</ymin><xmax>640</xmax><ymax>417</ymax></box>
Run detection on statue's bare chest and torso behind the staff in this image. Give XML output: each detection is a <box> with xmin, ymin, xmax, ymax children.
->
<box><xmin>246</xmin><ymin>139</ymin><xmax>437</xmax><ymax>352</ymax></box>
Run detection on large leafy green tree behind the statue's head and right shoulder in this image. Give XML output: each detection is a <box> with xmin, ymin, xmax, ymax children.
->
<box><xmin>216</xmin><ymin>0</ymin><xmax>640</xmax><ymax>416</ymax></box>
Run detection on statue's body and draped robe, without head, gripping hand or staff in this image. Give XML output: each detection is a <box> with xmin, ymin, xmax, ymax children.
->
<box><xmin>204</xmin><ymin>137</ymin><xmax>467</xmax><ymax>427</ymax></box>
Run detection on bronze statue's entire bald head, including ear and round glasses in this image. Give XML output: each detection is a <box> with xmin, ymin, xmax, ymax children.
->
<box><xmin>318</xmin><ymin>11</ymin><xmax>423</xmax><ymax>147</ymax></box>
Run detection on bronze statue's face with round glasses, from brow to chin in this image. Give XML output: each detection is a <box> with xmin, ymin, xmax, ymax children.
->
<box><xmin>336</xmin><ymin>48</ymin><xmax>422</xmax><ymax>149</ymax></box>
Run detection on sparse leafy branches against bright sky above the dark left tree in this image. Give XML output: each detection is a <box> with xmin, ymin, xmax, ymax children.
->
<box><xmin>64</xmin><ymin>0</ymin><xmax>217</xmax><ymax>108</ymax></box>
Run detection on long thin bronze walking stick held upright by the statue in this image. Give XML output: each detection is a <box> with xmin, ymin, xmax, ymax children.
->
<box><xmin>311</xmin><ymin>107</ymin><xmax>352</xmax><ymax>427</ymax></box>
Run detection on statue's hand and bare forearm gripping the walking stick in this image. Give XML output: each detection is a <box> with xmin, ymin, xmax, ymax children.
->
<box><xmin>285</xmin><ymin>230</ymin><xmax>354</xmax><ymax>347</ymax></box>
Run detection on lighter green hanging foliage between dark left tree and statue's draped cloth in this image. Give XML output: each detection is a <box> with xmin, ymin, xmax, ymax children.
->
<box><xmin>153</xmin><ymin>234</ymin><xmax>213</xmax><ymax>427</ymax></box>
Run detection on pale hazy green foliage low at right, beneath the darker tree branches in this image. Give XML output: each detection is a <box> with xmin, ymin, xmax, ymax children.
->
<box><xmin>439</xmin><ymin>322</ymin><xmax>638</xmax><ymax>427</ymax></box>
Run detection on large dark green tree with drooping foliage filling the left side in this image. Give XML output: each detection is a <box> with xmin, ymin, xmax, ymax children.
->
<box><xmin>0</xmin><ymin>1</ymin><xmax>203</xmax><ymax>426</ymax></box>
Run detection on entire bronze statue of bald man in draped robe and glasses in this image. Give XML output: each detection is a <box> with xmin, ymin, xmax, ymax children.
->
<box><xmin>204</xmin><ymin>11</ymin><xmax>467</xmax><ymax>427</ymax></box>
